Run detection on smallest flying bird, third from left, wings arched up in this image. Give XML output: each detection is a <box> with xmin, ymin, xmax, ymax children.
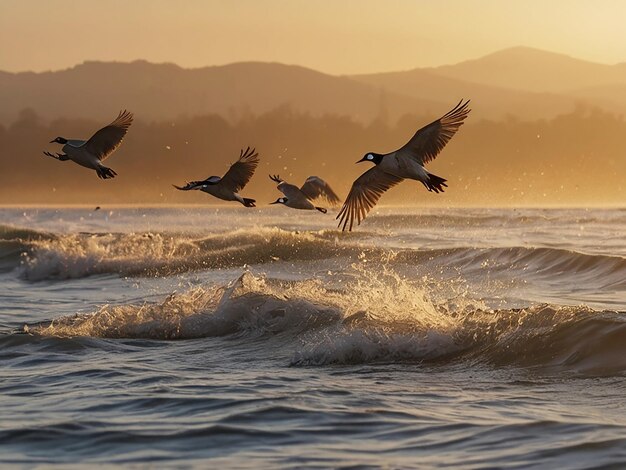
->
<box><xmin>270</xmin><ymin>175</ymin><xmax>341</xmax><ymax>214</ymax></box>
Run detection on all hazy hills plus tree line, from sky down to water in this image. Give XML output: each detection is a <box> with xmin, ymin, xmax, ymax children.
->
<box><xmin>0</xmin><ymin>48</ymin><xmax>626</xmax><ymax>205</ymax></box>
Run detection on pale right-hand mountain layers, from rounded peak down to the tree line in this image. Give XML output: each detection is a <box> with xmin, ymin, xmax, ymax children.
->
<box><xmin>350</xmin><ymin>47</ymin><xmax>626</xmax><ymax>119</ymax></box>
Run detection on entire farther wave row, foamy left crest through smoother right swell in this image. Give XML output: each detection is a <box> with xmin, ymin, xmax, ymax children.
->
<box><xmin>8</xmin><ymin>227</ymin><xmax>626</xmax><ymax>289</ymax></box>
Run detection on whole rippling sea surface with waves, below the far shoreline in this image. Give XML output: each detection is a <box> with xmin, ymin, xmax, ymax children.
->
<box><xmin>0</xmin><ymin>207</ymin><xmax>626</xmax><ymax>469</ymax></box>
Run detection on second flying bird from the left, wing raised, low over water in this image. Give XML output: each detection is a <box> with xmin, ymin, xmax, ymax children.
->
<box><xmin>172</xmin><ymin>147</ymin><xmax>259</xmax><ymax>207</ymax></box>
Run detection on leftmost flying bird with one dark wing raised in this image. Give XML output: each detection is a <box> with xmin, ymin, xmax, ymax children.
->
<box><xmin>44</xmin><ymin>110</ymin><xmax>133</xmax><ymax>179</ymax></box>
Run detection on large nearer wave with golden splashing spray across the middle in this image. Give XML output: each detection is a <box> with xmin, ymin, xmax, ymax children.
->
<box><xmin>17</xmin><ymin>267</ymin><xmax>626</xmax><ymax>375</ymax></box>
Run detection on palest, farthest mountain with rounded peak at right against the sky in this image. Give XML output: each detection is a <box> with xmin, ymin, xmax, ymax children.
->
<box><xmin>428</xmin><ymin>47</ymin><xmax>626</xmax><ymax>93</ymax></box>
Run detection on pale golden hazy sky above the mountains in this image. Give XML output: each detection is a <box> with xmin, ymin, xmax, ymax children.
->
<box><xmin>0</xmin><ymin>0</ymin><xmax>626</xmax><ymax>74</ymax></box>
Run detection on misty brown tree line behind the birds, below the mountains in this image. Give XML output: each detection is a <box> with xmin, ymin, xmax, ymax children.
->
<box><xmin>0</xmin><ymin>103</ymin><xmax>626</xmax><ymax>206</ymax></box>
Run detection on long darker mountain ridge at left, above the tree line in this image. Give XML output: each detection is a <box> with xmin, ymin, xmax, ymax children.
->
<box><xmin>0</xmin><ymin>61</ymin><xmax>449</xmax><ymax>123</ymax></box>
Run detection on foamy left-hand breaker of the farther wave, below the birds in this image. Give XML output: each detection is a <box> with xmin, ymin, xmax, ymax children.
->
<box><xmin>12</xmin><ymin>228</ymin><xmax>360</xmax><ymax>281</ymax></box>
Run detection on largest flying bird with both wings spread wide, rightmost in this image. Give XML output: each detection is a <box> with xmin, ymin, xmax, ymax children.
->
<box><xmin>336</xmin><ymin>100</ymin><xmax>471</xmax><ymax>231</ymax></box>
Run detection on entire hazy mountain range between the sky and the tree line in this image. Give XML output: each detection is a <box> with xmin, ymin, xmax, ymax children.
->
<box><xmin>0</xmin><ymin>47</ymin><xmax>626</xmax><ymax>124</ymax></box>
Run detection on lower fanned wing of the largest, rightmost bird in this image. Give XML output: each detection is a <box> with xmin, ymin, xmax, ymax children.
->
<box><xmin>336</xmin><ymin>166</ymin><xmax>404</xmax><ymax>231</ymax></box>
